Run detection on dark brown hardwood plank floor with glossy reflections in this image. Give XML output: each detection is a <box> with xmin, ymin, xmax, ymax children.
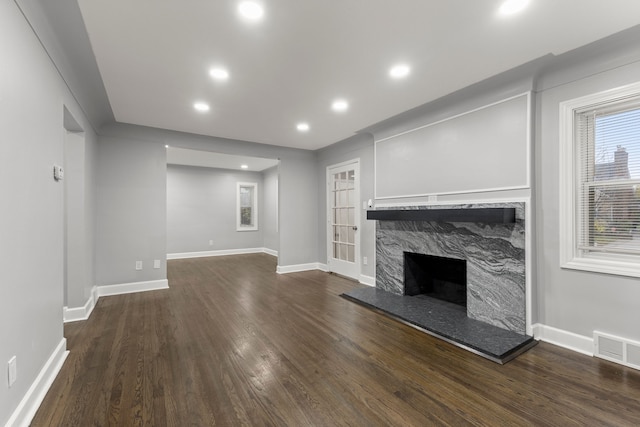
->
<box><xmin>32</xmin><ymin>254</ymin><xmax>640</xmax><ymax>426</ymax></box>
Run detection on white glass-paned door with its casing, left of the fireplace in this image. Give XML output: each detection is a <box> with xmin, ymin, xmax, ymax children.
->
<box><xmin>327</xmin><ymin>159</ymin><xmax>360</xmax><ymax>280</ymax></box>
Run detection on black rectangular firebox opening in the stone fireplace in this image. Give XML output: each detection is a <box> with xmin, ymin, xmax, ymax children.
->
<box><xmin>404</xmin><ymin>252</ymin><xmax>467</xmax><ymax>308</ymax></box>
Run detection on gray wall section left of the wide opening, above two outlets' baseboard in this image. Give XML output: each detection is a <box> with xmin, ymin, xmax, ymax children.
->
<box><xmin>96</xmin><ymin>136</ymin><xmax>167</xmax><ymax>286</ymax></box>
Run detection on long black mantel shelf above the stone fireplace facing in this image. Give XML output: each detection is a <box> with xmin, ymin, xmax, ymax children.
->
<box><xmin>367</xmin><ymin>208</ymin><xmax>516</xmax><ymax>224</ymax></box>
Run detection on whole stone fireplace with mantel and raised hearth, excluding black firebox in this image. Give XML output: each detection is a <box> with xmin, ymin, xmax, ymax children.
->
<box><xmin>342</xmin><ymin>202</ymin><xmax>537</xmax><ymax>364</ymax></box>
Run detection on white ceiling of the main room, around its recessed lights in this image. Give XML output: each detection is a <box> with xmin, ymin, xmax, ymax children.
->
<box><xmin>78</xmin><ymin>0</ymin><xmax>640</xmax><ymax>149</ymax></box>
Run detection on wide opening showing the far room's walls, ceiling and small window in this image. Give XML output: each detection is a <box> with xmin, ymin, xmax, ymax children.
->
<box><xmin>166</xmin><ymin>146</ymin><xmax>280</xmax><ymax>270</ymax></box>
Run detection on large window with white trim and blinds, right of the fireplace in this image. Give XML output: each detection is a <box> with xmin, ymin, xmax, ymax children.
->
<box><xmin>560</xmin><ymin>83</ymin><xmax>640</xmax><ymax>277</ymax></box>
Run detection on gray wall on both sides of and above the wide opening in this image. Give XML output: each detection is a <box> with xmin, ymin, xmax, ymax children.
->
<box><xmin>97</xmin><ymin>124</ymin><xmax>318</xmax><ymax>270</ymax></box>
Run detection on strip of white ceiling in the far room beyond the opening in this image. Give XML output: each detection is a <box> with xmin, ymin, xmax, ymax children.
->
<box><xmin>167</xmin><ymin>147</ymin><xmax>279</xmax><ymax>172</ymax></box>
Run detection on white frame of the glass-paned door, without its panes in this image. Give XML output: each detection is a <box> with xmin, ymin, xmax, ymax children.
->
<box><xmin>325</xmin><ymin>157</ymin><xmax>362</xmax><ymax>281</ymax></box>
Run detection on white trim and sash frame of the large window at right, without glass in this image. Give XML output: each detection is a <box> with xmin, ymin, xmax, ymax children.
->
<box><xmin>559</xmin><ymin>82</ymin><xmax>640</xmax><ymax>277</ymax></box>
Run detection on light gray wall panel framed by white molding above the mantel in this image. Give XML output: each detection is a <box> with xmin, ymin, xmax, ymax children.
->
<box><xmin>375</xmin><ymin>94</ymin><xmax>531</xmax><ymax>199</ymax></box>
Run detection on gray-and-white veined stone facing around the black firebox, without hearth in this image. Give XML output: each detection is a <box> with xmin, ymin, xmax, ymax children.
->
<box><xmin>376</xmin><ymin>203</ymin><xmax>526</xmax><ymax>334</ymax></box>
